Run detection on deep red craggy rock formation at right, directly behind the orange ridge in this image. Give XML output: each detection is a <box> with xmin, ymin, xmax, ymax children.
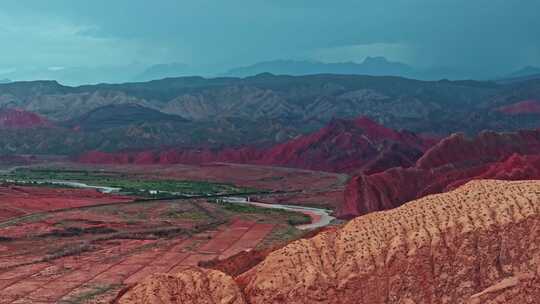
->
<box><xmin>338</xmin><ymin>130</ymin><xmax>540</xmax><ymax>218</ymax></box>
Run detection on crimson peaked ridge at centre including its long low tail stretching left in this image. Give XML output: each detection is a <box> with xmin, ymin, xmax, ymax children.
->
<box><xmin>79</xmin><ymin>117</ymin><xmax>435</xmax><ymax>173</ymax></box>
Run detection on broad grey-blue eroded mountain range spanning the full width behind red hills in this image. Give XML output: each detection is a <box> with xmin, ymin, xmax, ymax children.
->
<box><xmin>0</xmin><ymin>73</ymin><xmax>540</xmax><ymax>155</ymax></box>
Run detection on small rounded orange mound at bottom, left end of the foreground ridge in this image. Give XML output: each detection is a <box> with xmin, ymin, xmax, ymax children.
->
<box><xmin>116</xmin><ymin>268</ymin><xmax>246</xmax><ymax>304</ymax></box>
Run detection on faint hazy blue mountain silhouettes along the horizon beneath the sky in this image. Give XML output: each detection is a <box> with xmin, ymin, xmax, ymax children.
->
<box><xmin>4</xmin><ymin>57</ymin><xmax>540</xmax><ymax>86</ymax></box>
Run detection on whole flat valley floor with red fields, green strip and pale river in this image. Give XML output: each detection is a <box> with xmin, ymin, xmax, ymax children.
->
<box><xmin>0</xmin><ymin>159</ymin><xmax>344</xmax><ymax>303</ymax></box>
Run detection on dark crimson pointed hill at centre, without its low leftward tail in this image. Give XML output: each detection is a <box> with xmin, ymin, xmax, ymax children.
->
<box><xmin>260</xmin><ymin>117</ymin><xmax>433</xmax><ymax>173</ymax></box>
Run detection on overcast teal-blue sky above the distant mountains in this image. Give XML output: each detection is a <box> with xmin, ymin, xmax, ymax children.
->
<box><xmin>0</xmin><ymin>0</ymin><xmax>540</xmax><ymax>78</ymax></box>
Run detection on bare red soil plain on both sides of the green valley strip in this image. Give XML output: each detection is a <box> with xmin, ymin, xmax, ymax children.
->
<box><xmin>0</xmin><ymin>163</ymin><xmax>346</xmax><ymax>304</ymax></box>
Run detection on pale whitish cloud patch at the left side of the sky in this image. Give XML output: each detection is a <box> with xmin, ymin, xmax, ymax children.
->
<box><xmin>0</xmin><ymin>13</ymin><xmax>170</xmax><ymax>67</ymax></box>
